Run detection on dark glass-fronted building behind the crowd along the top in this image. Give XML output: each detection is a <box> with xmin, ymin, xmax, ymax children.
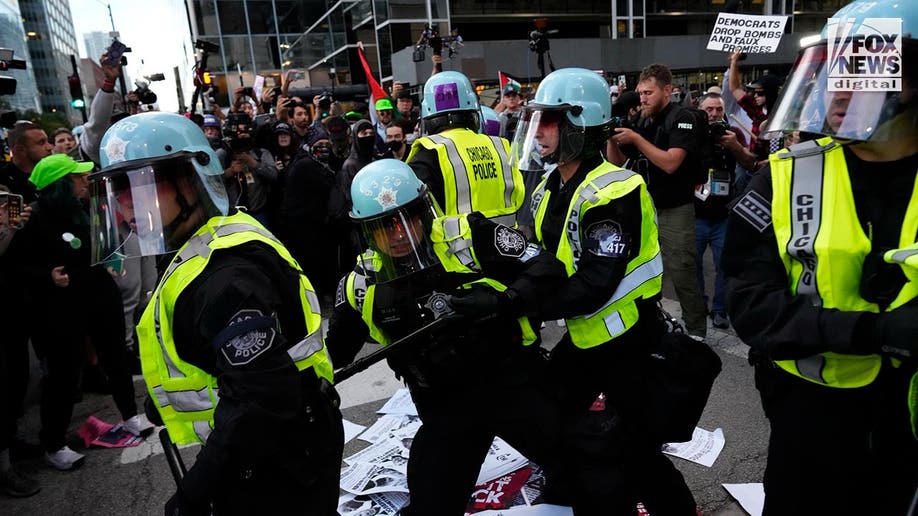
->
<box><xmin>187</xmin><ymin>0</ymin><xmax>848</xmax><ymax>104</ymax></box>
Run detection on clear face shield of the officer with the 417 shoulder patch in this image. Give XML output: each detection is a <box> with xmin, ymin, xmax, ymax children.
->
<box><xmin>510</xmin><ymin>105</ymin><xmax>585</xmax><ymax>171</ymax></box>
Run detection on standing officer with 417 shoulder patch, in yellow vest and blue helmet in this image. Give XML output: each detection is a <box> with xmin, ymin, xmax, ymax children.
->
<box><xmin>513</xmin><ymin>68</ymin><xmax>695</xmax><ymax>516</ymax></box>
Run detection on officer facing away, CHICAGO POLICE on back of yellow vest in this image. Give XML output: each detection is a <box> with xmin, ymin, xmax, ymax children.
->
<box><xmin>408</xmin><ymin>71</ymin><xmax>524</xmax><ymax>226</ymax></box>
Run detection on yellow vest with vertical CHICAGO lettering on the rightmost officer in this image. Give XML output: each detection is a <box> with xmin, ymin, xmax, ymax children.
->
<box><xmin>769</xmin><ymin>138</ymin><xmax>918</xmax><ymax>388</ymax></box>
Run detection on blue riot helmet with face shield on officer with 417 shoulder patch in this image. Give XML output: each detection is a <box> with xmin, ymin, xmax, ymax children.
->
<box><xmin>511</xmin><ymin>68</ymin><xmax>612</xmax><ymax>170</ymax></box>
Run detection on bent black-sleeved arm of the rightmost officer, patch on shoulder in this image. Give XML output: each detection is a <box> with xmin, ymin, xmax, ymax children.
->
<box><xmin>722</xmin><ymin>167</ymin><xmax>904</xmax><ymax>360</ymax></box>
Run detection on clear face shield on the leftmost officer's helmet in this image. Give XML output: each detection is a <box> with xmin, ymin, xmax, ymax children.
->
<box><xmin>90</xmin><ymin>153</ymin><xmax>222</xmax><ymax>264</ymax></box>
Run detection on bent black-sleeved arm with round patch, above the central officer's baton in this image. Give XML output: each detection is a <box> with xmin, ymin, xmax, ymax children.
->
<box><xmin>450</xmin><ymin>212</ymin><xmax>566</xmax><ymax>317</ymax></box>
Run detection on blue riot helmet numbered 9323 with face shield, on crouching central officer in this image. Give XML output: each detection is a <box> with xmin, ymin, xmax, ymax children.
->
<box><xmin>351</xmin><ymin>159</ymin><xmax>440</xmax><ymax>283</ymax></box>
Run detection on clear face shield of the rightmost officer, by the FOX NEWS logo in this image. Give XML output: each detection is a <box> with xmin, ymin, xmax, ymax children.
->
<box><xmin>762</xmin><ymin>40</ymin><xmax>918</xmax><ymax>142</ymax></box>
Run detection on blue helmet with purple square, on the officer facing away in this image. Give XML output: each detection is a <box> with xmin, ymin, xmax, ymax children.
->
<box><xmin>421</xmin><ymin>71</ymin><xmax>481</xmax><ymax>134</ymax></box>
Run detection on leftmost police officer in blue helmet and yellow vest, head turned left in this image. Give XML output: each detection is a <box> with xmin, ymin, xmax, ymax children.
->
<box><xmin>91</xmin><ymin>113</ymin><xmax>343</xmax><ymax>516</ymax></box>
